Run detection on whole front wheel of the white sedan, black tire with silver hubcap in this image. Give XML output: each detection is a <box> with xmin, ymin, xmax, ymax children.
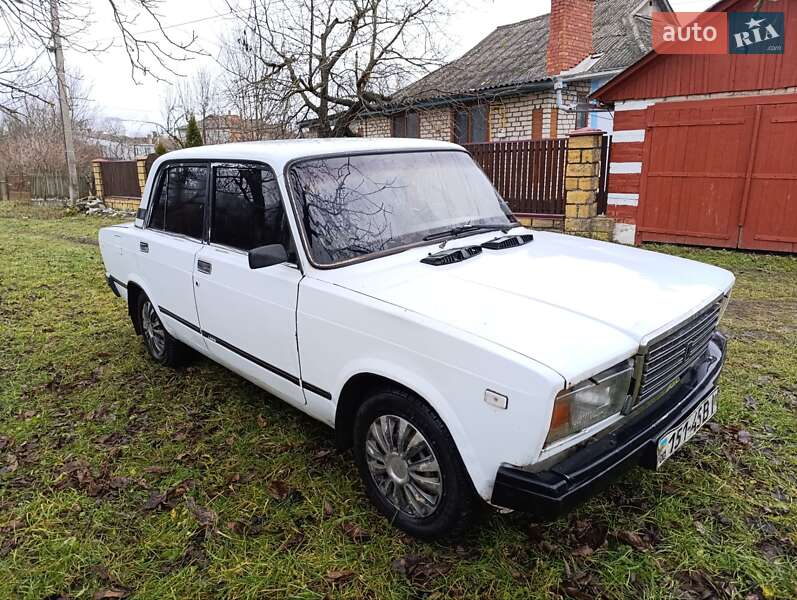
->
<box><xmin>354</xmin><ymin>387</ymin><xmax>480</xmax><ymax>539</ymax></box>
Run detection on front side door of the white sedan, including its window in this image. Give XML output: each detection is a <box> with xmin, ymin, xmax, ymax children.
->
<box><xmin>194</xmin><ymin>163</ymin><xmax>305</xmax><ymax>405</ymax></box>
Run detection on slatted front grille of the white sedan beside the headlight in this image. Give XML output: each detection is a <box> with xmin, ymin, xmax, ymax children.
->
<box><xmin>635</xmin><ymin>296</ymin><xmax>725</xmax><ymax>404</ymax></box>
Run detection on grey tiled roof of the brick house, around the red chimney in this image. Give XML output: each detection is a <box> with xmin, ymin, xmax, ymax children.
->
<box><xmin>393</xmin><ymin>0</ymin><xmax>669</xmax><ymax>104</ymax></box>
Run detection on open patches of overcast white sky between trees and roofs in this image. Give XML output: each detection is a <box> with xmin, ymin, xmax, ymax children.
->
<box><xmin>66</xmin><ymin>0</ymin><xmax>714</xmax><ymax>134</ymax></box>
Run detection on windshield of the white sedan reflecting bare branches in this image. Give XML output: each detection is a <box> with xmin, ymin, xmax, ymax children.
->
<box><xmin>290</xmin><ymin>151</ymin><xmax>512</xmax><ymax>265</ymax></box>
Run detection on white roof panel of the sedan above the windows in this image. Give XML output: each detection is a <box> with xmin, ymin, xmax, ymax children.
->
<box><xmin>158</xmin><ymin>138</ymin><xmax>463</xmax><ymax>170</ymax></box>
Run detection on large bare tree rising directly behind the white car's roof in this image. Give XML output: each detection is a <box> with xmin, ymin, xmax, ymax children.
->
<box><xmin>228</xmin><ymin>0</ymin><xmax>448</xmax><ymax>137</ymax></box>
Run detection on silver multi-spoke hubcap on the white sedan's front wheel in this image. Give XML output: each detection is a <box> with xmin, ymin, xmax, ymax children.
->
<box><xmin>365</xmin><ymin>415</ymin><xmax>443</xmax><ymax>518</ymax></box>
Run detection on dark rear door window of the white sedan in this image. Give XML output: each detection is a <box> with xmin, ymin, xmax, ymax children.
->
<box><xmin>148</xmin><ymin>166</ymin><xmax>208</xmax><ymax>239</ymax></box>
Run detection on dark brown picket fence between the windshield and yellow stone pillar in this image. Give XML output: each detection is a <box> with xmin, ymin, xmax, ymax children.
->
<box><xmin>465</xmin><ymin>139</ymin><xmax>567</xmax><ymax>216</ymax></box>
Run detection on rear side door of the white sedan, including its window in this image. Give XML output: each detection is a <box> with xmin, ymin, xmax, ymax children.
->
<box><xmin>138</xmin><ymin>162</ymin><xmax>210</xmax><ymax>350</ymax></box>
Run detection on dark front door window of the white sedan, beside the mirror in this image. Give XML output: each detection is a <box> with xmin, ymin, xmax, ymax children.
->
<box><xmin>210</xmin><ymin>166</ymin><xmax>290</xmax><ymax>250</ymax></box>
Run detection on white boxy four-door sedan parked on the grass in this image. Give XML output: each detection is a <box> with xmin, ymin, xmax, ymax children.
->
<box><xmin>100</xmin><ymin>139</ymin><xmax>734</xmax><ymax>538</ymax></box>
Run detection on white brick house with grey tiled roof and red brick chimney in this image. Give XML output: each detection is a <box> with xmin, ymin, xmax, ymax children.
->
<box><xmin>301</xmin><ymin>0</ymin><xmax>671</xmax><ymax>143</ymax></box>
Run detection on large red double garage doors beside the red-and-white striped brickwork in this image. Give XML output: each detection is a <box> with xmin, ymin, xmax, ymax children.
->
<box><xmin>637</xmin><ymin>95</ymin><xmax>797</xmax><ymax>252</ymax></box>
